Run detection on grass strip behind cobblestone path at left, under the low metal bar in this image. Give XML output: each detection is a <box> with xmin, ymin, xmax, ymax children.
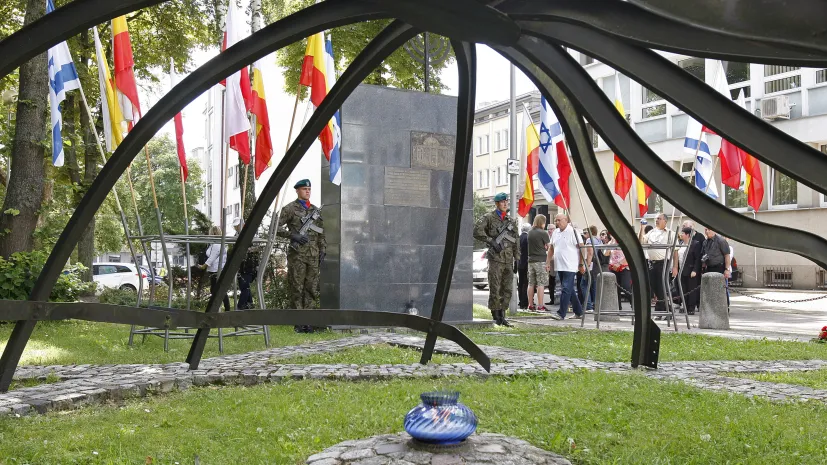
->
<box><xmin>0</xmin><ymin>320</ymin><xmax>347</xmax><ymax>366</ymax></box>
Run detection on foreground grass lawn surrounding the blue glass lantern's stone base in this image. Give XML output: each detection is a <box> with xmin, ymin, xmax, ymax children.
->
<box><xmin>0</xmin><ymin>371</ymin><xmax>827</xmax><ymax>464</ymax></box>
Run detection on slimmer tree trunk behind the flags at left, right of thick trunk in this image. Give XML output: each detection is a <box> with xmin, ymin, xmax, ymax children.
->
<box><xmin>77</xmin><ymin>31</ymin><xmax>95</xmax><ymax>282</ymax></box>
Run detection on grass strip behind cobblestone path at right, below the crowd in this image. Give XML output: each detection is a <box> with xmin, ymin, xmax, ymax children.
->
<box><xmin>468</xmin><ymin>327</ymin><xmax>827</xmax><ymax>362</ymax></box>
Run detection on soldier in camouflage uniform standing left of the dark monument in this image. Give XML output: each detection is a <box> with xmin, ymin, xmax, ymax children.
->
<box><xmin>278</xmin><ymin>179</ymin><xmax>327</xmax><ymax>333</ymax></box>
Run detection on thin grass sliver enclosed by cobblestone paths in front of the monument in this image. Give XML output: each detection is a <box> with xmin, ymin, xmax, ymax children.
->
<box><xmin>270</xmin><ymin>344</ymin><xmax>477</xmax><ymax>365</ymax></box>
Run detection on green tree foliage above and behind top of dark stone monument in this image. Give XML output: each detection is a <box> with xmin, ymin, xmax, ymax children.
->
<box><xmin>262</xmin><ymin>0</ymin><xmax>454</xmax><ymax>96</ymax></box>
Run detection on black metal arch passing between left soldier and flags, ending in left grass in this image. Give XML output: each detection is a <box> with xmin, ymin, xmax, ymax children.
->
<box><xmin>187</xmin><ymin>21</ymin><xmax>419</xmax><ymax>369</ymax></box>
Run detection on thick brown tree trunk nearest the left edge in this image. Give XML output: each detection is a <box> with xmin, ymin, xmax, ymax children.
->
<box><xmin>0</xmin><ymin>0</ymin><xmax>49</xmax><ymax>257</ymax></box>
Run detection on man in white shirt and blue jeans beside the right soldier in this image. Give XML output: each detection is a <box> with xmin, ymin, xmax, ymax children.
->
<box><xmin>546</xmin><ymin>214</ymin><xmax>586</xmax><ymax>320</ymax></box>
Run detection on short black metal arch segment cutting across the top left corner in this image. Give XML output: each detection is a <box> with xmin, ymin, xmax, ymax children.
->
<box><xmin>0</xmin><ymin>0</ymin><xmax>167</xmax><ymax>77</ymax></box>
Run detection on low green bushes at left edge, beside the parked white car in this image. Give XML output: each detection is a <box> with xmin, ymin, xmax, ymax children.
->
<box><xmin>0</xmin><ymin>251</ymin><xmax>95</xmax><ymax>302</ymax></box>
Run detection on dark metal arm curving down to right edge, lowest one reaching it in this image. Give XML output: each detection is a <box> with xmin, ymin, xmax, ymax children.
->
<box><xmin>516</xmin><ymin>37</ymin><xmax>827</xmax><ymax>267</ymax></box>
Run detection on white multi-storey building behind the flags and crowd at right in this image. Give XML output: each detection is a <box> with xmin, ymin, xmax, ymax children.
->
<box><xmin>474</xmin><ymin>51</ymin><xmax>827</xmax><ymax>289</ymax></box>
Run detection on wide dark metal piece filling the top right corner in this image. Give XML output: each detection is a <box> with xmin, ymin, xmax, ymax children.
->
<box><xmin>627</xmin><ymin>0</ymin><xmax>827</xmax><ymax>52</ymax></box>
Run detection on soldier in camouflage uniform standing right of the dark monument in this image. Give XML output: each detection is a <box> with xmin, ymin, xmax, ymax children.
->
<box><xmin>474</xmin><ymin>192</ymin><xmax>520</xmax><ymax>326</ymax></box>
